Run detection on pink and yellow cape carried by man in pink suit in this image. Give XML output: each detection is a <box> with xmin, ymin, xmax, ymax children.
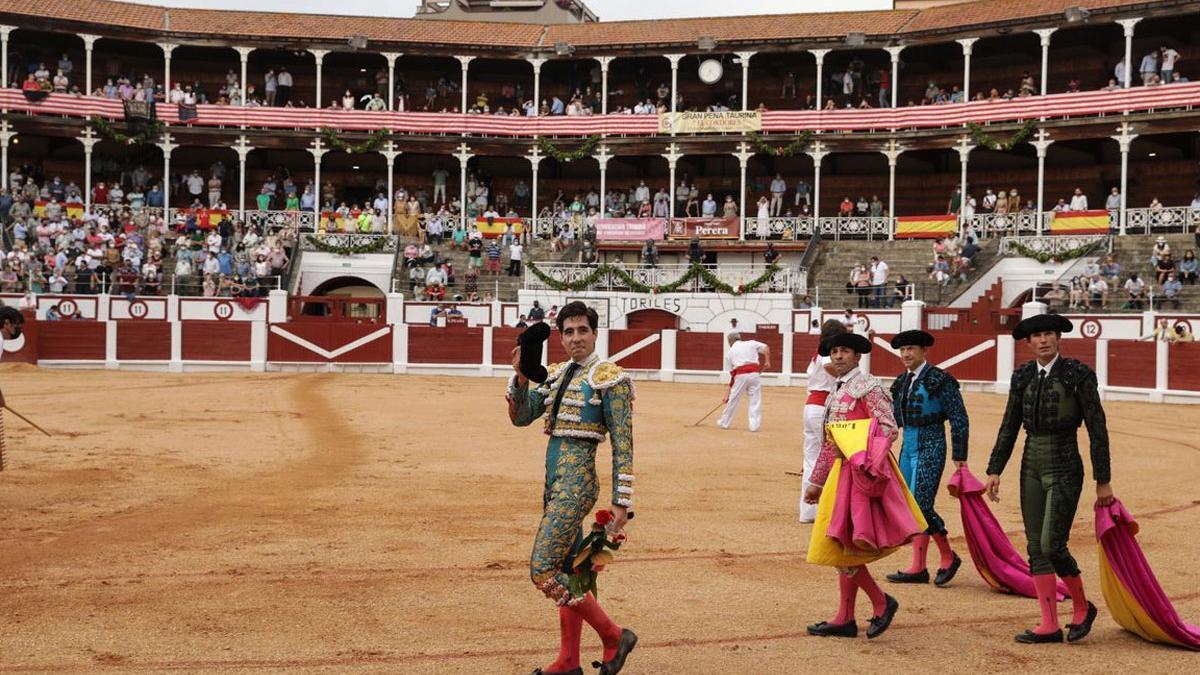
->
<box><xmin>827</xmin><ymin>419</ymin><xmax>926</xmax><ymax>551</ymax></box>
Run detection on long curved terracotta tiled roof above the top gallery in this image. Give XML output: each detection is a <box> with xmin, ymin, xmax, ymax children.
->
<box><xmin>0</xmin><ymin>0</ymin><xmax>1175</xmax><ymax>49</ymax></box>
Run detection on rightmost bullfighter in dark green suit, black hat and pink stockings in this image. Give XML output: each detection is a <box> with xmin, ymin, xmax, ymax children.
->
<box><xmin>988</xmin><ymin>313</ymin><xmax>1114</xmax><ymax>644</ymax></box>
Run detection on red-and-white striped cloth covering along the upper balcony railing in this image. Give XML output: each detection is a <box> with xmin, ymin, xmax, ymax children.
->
<box><xmin>9</xmin><ymin>83</ymin><xmax>1200</xmax><ymax>137</ymax></box>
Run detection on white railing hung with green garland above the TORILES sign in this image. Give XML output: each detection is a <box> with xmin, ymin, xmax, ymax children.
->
<box><xmin>524</xmin><ymin>262</ymin><xmax>808</xmax><ymax>293</ymax></box>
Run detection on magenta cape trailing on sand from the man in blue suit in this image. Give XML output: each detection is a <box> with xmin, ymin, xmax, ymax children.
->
<box><xmin>947</xmin><ymin>466</ymin><xmax>1069</xmax><ymax>599</ymax></box>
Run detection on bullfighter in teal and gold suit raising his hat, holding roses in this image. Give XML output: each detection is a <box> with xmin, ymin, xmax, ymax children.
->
<box><xmin>508</xmin><ymin>303</ymin><xmax>637</xmax><ymax>675</ymax></box>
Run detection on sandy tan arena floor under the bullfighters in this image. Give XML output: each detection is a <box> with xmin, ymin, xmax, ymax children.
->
<box><xmin>0</xmin><ymin>365</ymin><xmax>1200</xmax><ymax>675</ymax></box>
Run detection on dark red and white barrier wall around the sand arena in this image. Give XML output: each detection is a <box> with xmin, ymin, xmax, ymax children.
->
<box><xmin>2</xmin><ymin>291</ymin><xmax>1200</xmax><ymax>402</ymax></box>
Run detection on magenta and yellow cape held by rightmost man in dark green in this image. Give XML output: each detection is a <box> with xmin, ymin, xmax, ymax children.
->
<box><xmin>1096</xmin><ymin>500</ymin><xmax>1200</xmax><ymax>650</ymax></box>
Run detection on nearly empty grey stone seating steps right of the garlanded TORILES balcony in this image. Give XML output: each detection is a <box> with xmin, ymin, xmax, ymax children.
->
<box><xmin>809</xmin><ymin>239</ymin><xmax>1000</xmax><ymax>309</ymax></box>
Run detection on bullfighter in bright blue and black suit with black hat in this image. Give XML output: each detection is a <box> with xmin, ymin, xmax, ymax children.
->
<box><xmin>888</xmin><ymin>330</ymin><xmax>970</xmax><ymax>586</ymax></box>
